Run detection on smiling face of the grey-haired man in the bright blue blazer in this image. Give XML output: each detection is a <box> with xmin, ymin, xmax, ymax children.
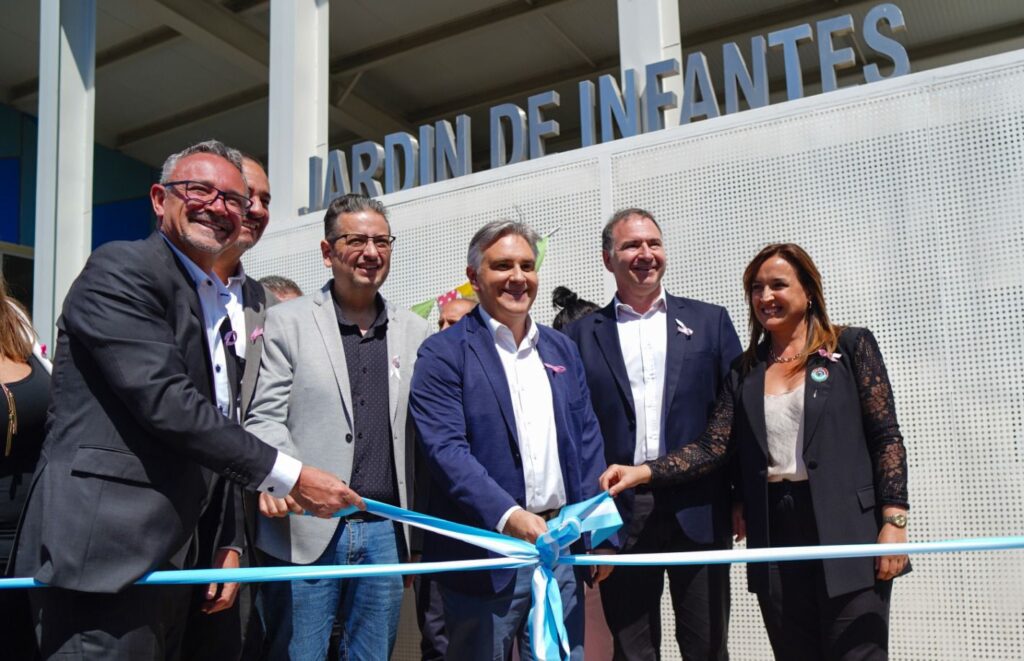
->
<box><xmin>466</xmin><ymin>234</ymin><xmax>538</xmax><ymax>329</ymax></box>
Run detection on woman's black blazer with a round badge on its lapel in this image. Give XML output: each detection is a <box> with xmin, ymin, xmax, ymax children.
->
<box><xmin>701</xmin><ymin>327</ymin><xmax>906</xmax><ymax>597</ymax></box>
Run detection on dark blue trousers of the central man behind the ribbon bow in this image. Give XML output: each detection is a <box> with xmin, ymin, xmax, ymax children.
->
<box><xmin>440</xmin><ymin>565</ymin><xmax>585</xmax><ymax>661</ymax></box>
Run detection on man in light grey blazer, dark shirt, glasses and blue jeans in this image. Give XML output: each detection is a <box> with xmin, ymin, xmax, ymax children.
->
<box><xmin>246</xmin><ymin>194</ymin><xmax>428</xmax><ymax>661</ymax></box>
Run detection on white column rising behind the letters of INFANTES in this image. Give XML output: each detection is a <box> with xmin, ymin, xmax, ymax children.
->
<box><xmin>618</xmin><ymin>0</ymin><xmax>683</xmax><ymax>126</ymax></box>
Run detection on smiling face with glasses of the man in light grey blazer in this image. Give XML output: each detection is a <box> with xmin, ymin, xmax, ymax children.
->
<box><xmin>321</xmin><ymin>210</ymin><xmax>391</xmax><ymax>295</ymax></box>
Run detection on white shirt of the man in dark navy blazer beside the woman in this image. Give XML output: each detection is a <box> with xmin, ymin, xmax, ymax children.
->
<box><xmin>614</xmin><ymin>289</ymin><xmax>668</xmax><ymax>465</ymax></box>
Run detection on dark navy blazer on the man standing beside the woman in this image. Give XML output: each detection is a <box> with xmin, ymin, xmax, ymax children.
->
<box><xmin>565</xmin><ymin>294</ymin><xmax>740</xmax><ymax>549</ymax></box>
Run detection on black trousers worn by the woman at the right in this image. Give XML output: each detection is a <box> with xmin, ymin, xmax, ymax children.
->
<box><xmin>758</xmin><ymin>482</ymin><xmax>892</xmax><ymax>661</ymax></box>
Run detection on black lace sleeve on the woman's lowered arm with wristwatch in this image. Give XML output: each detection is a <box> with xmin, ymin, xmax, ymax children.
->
<box><xmin>851</xmin><ymin>329</ymin><xmax>909</xmax><ymax>508</ymax></box>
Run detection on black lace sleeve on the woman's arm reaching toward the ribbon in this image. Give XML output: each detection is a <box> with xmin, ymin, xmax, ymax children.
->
<box><xmin>647</xmin><ymin>383</ymin><xmax>735</xmax><ymax>487</ymax></box>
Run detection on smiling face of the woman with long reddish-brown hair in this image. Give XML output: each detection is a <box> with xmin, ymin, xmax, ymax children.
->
<box><xmin>749</xmin><ymin>255</ymin><xmax>810</xmax><ymax>337</ymax></box>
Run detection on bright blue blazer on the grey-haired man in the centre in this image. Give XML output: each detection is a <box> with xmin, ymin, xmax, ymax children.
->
<box><xmin>409</xmin><ymin>310</ymin><xmax>605</xmax><ymax>593</ymax></box>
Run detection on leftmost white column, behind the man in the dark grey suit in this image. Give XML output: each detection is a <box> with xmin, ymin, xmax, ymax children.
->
<box><xmin>32</xmin><ymin>0</ymin><xmax>96</xmax><ymax>347</ymax></box>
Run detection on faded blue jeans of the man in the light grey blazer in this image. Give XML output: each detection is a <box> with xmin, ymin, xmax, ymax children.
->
<box><xmin>258</xmin><ymin>520</ymin><xmax>402</xmax><ymax>661</ymax></box>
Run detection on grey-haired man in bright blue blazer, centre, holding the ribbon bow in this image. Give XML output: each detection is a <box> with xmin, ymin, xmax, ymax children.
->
<box><xmin>410</xmin><ymin>221</ymin><xmax>608</xmax><ymax>659</ymax></box>
